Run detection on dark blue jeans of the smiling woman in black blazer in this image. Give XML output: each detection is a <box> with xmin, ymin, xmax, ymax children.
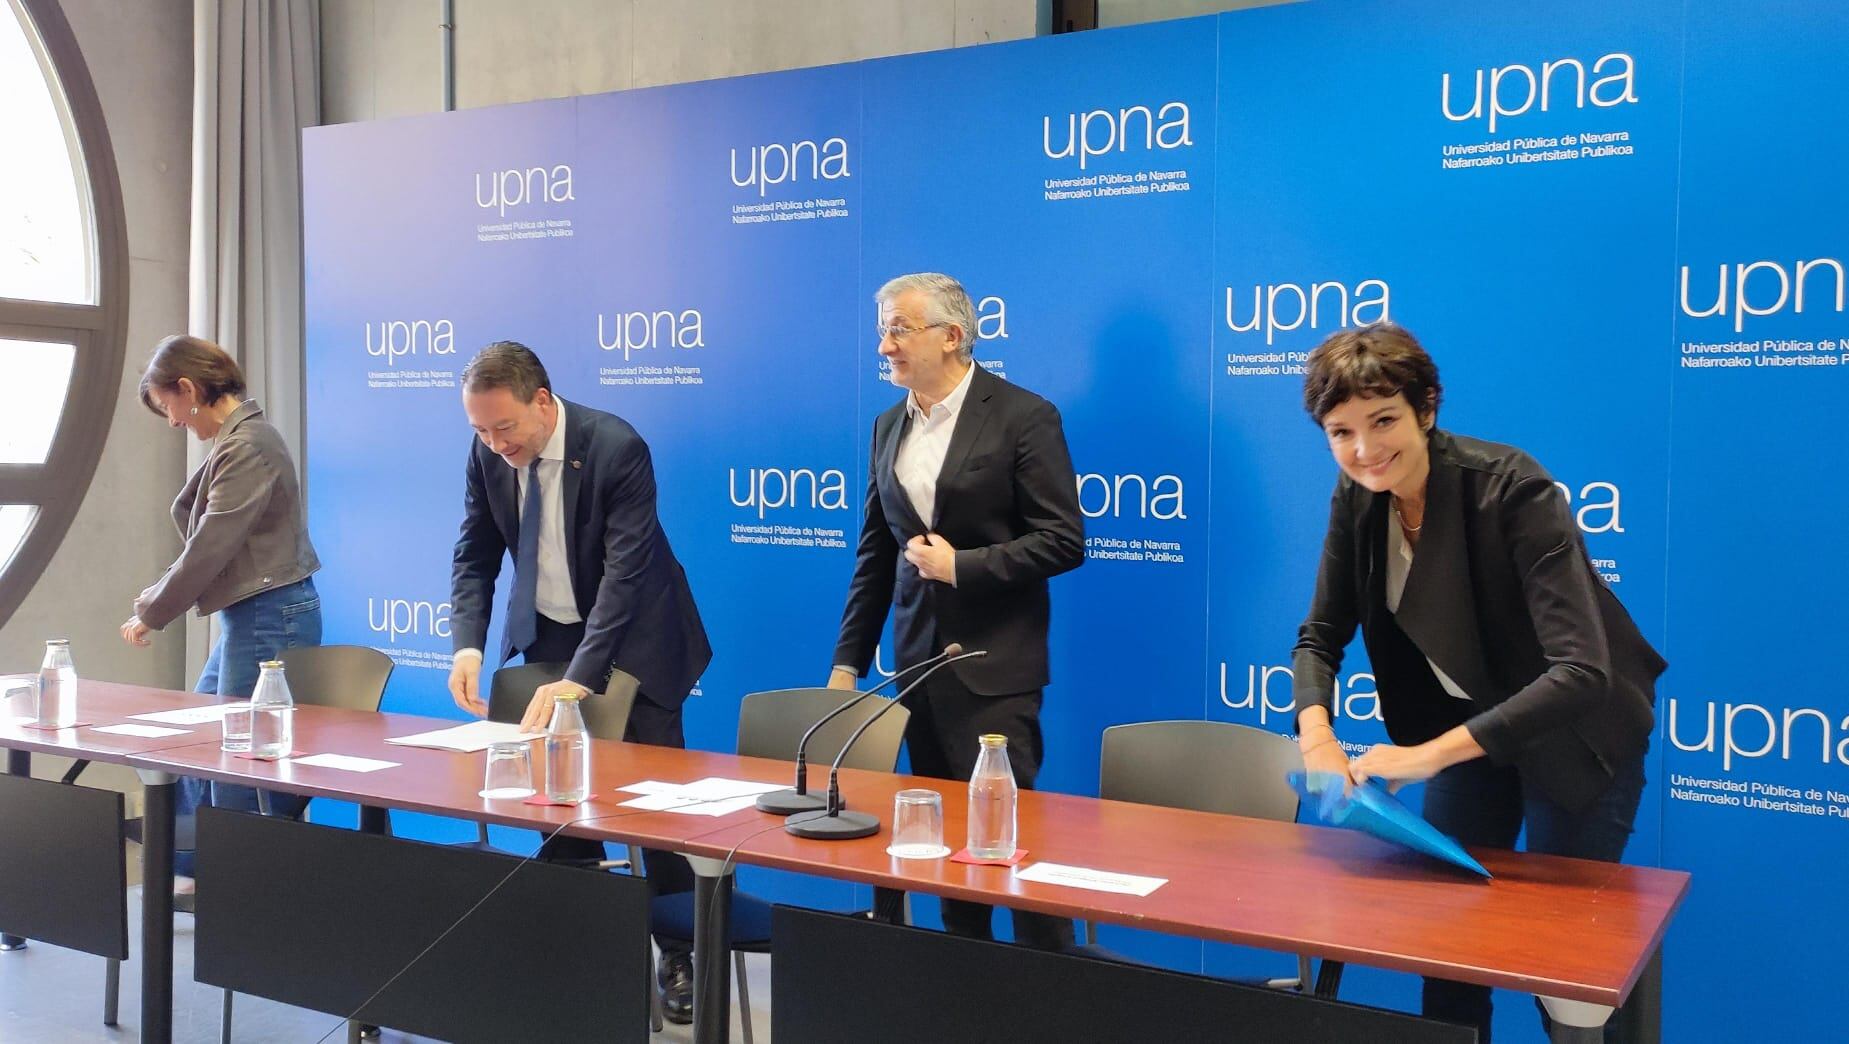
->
<box><xmin>1420</xmin><ymin>756</ymin><xmax>1644</xmax><ymax>1044</ymax></box>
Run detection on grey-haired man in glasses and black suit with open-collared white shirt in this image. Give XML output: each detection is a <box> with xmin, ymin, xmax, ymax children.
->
<box><xmin>828</xmin><ymin>273</ymin><xmax>1085</xmax><ymax>950</ymax></box>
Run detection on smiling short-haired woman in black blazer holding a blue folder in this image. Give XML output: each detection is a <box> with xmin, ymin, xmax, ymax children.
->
<box><xmin>1292</xmin><ymin>323</ymin><xmax>1666</xmax><ymax>1042</ymax></box>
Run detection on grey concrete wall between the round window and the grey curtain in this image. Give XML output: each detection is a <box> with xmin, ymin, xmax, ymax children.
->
<box><xmin>0</xmin><ymin>0</ymin><xmax>192</xmax><ymax>782</ymax></box>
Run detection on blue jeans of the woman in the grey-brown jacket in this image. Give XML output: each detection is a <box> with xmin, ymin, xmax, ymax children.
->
<box><xmin>174</xmin><ymin>578</ymin><xmax>322</xmax><ymax>864</ymax></box>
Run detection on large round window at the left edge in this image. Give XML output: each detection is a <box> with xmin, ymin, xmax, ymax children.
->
<box><xmin>0</xmin><ymin>0</ymin><xmax>128</xmax><ymax>623</ymax></box>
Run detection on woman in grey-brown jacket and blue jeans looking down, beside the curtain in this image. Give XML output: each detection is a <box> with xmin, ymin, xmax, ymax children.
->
<box><xmin>122</xmin><ymin>334</ymin><xmax>322</xmax><ymax>831</ymax></box>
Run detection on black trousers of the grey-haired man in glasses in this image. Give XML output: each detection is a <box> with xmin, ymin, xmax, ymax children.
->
<box><xmin>873</xmin><ymin>667</ymin><xmax>1072</xmax><ymax>950</ymax></box>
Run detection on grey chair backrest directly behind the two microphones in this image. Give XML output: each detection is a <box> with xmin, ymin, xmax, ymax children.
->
<box><xmin>738</xmin><ymin>689</ymin><xmax>912</xmax><ymax>772</ymax></box>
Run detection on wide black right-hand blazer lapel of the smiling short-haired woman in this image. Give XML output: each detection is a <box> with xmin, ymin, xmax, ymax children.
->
<box><xmin>1396</xmin><ymin>432</ymin><xmax>1492</xmax><ymax>698</ymax></box>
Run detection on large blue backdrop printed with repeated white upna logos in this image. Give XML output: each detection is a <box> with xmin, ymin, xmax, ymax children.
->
<box><xmin>303</xmin><ymin>0</ymin><xmax>1849</xmax><ymax>1040</ymax></box>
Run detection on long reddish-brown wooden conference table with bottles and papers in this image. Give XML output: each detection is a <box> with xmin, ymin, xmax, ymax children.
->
<box><xmin>0</xmin><ymin>682</ymin><xmax>1688</xmax><ymax>1042</ymax></box>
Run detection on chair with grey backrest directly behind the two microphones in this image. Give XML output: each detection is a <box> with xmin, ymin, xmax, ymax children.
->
<box><xmin>649</xmin><ymin>689</ymin><xmax>912</xmax><ymax>1044</ymax></box>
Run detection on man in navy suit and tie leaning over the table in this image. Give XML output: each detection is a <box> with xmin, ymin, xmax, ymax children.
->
<box><xmin>449</xmin><ymin>342</ymin><xmax>712</xmax><ymax>1022</ymax></box>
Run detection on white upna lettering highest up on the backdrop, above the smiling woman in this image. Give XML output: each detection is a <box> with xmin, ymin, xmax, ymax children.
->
<box><xmin>1439</xmin><ymin>52</ymin><xmax>1636</xmax><ymax>133</ymax></box>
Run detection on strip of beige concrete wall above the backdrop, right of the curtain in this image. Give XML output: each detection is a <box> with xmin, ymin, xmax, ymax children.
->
<box><xmin>322</xmin><ymin>0</ymin><xmax>1045</xmax><ymax>124</ymax></box>
